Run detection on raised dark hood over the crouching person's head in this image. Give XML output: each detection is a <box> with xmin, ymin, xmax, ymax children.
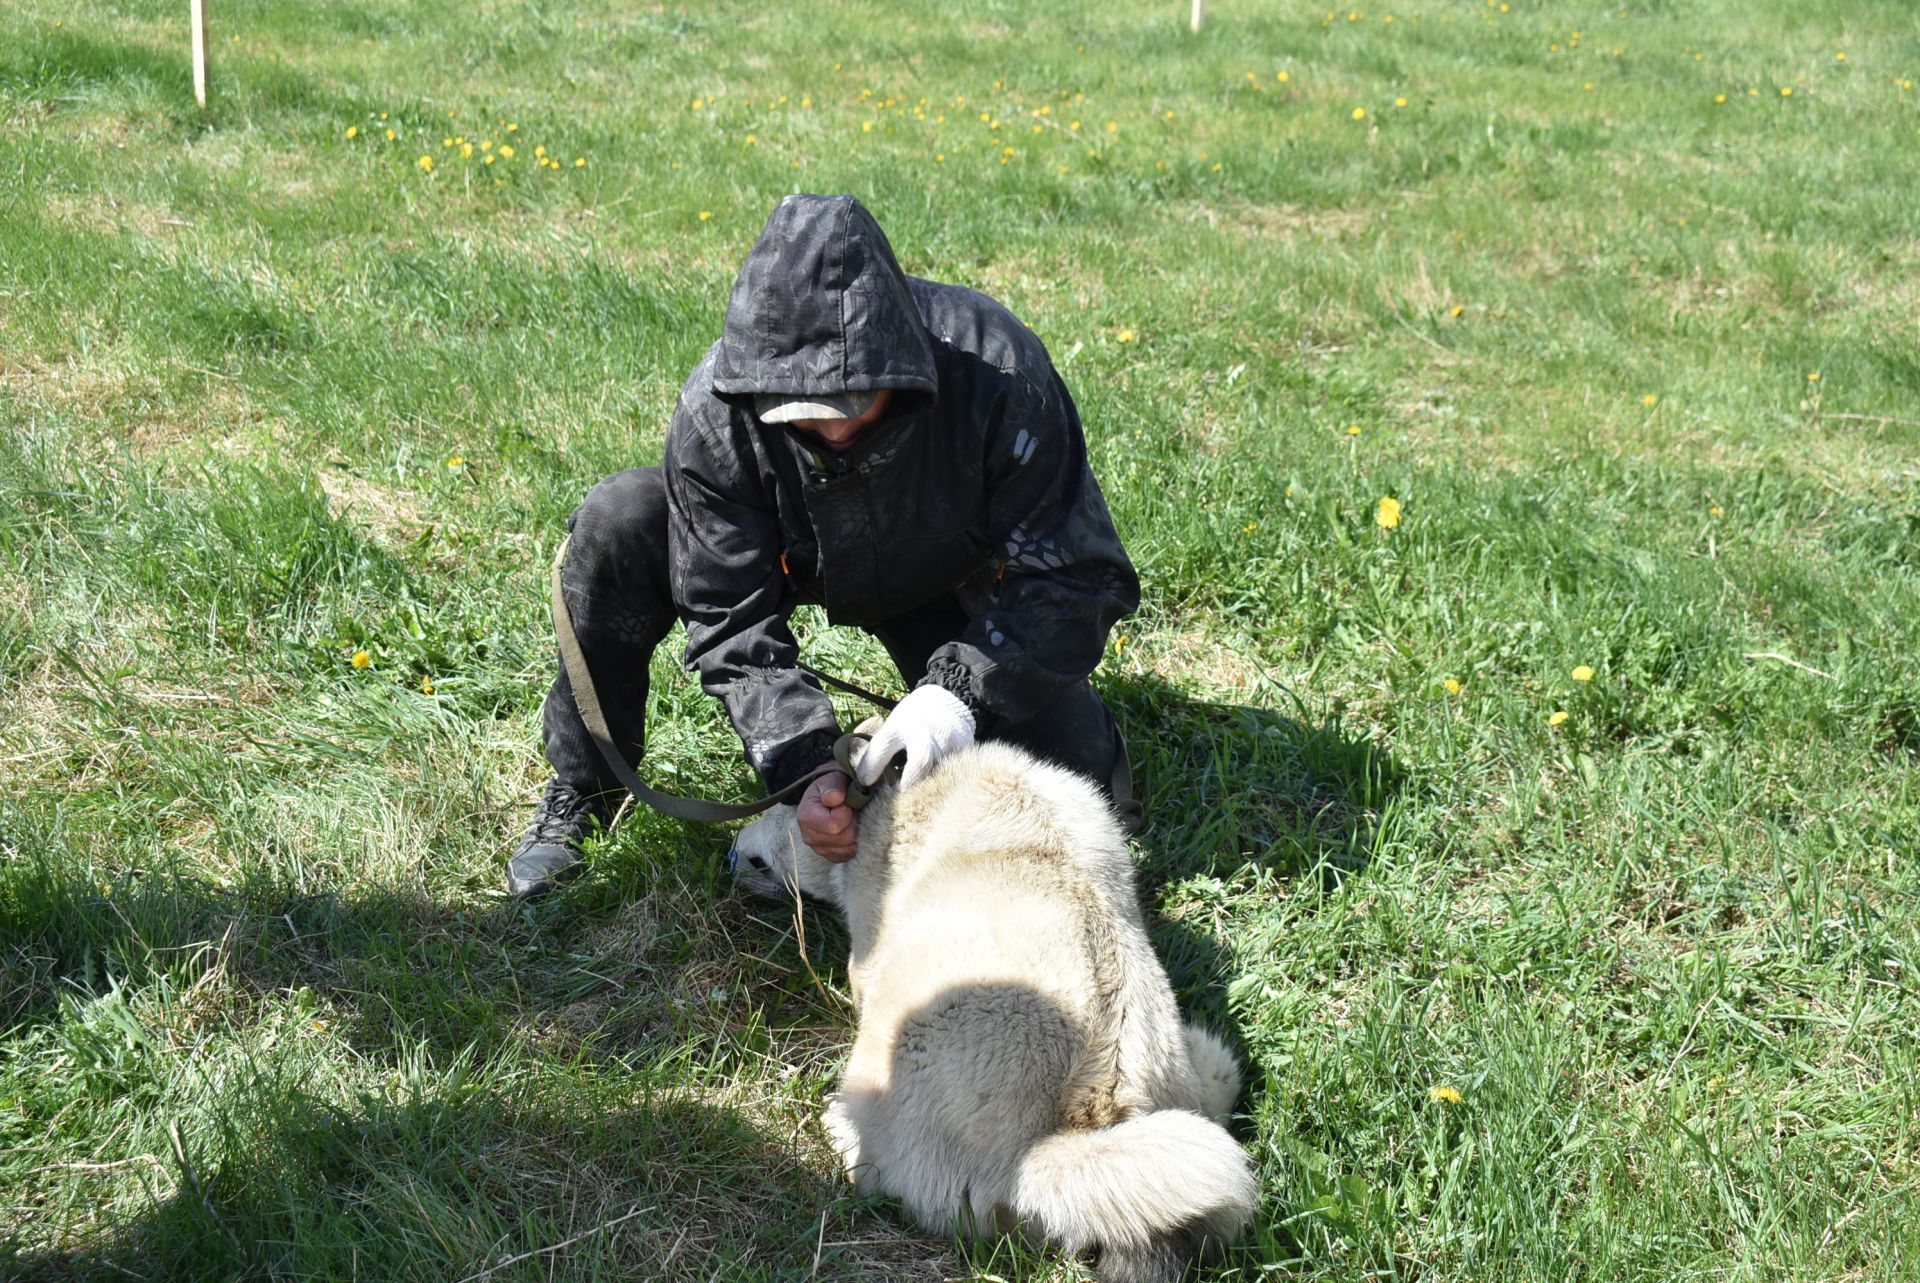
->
<box><xmin>712</xmin><ymin>196</ymin><xmax>937</xmax><ymax>409</ymax></box>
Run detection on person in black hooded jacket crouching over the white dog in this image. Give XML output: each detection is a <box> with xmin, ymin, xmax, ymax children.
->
<box><xmin>507</xmin><ymin>196</ymin><xmax>1140</xmax><ymax>895</ymax></box>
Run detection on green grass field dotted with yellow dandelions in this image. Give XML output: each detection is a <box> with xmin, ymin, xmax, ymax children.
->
<box><xmin>0</xmin><ymin>0</ymin><xmax>1920</xmax><ymax>1283</ymax></box>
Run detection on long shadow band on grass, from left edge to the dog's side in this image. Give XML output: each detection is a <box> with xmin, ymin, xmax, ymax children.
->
<box><xmin>0</xmin><ymin>837</ymin><xmax>845</xmax><ymax>1064</ymax></box>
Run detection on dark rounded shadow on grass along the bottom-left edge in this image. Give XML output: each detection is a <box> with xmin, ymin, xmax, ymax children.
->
<box><xmin>0</xmin><ymin>1066</ymin><xmax>939</xmax><ymax>1281</ymax></box>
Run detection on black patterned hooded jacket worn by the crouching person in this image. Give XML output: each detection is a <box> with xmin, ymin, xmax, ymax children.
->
<box><xmin>664</xmin><ymin>196</ymin><xmax>1140</xmax><ymax>787</ymax></box>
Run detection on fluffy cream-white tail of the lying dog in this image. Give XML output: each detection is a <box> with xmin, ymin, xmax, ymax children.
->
<box><xmin>1014</xmin><ymin>1110</ymin><xmax>1256</xmax><ymax>1283</ymax></box>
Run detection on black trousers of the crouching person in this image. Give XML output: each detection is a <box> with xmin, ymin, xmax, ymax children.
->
<box><xmin>541</xmin><ymin>469</ymin><xmax>1121</xmax><ymax>810</ymax></box>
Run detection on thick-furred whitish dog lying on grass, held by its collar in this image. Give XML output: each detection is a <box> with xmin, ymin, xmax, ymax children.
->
<box><xmin>733</xmin><ymin>743</ymin><xmax>1256</xmax><ymax>1283</ymax></box>
